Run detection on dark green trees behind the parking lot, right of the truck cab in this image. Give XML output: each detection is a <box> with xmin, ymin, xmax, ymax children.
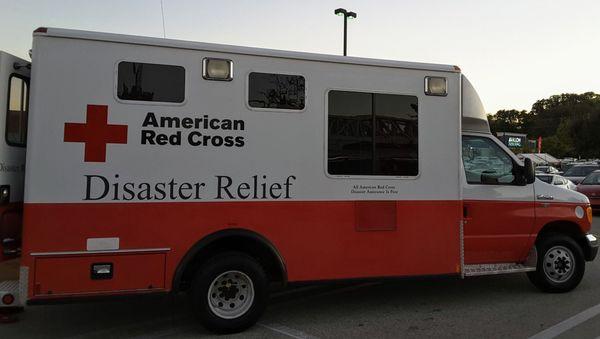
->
<box><xmin>488</xmin><ymin>92</ymin><xmax>600</xmax><ymax>159</ymax></box>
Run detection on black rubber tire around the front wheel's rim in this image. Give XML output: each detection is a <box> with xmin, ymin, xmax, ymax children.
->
<box><xmin>527</xmin><ymin>233</ymin><xmax>585</xmax><ymax>293</ymax></box>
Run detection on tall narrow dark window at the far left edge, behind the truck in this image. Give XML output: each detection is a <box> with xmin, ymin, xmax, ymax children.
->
<box><xmin>5</xmin><ymin>74</ymin><xmax>29</xmax><ymax>147</ymax></box>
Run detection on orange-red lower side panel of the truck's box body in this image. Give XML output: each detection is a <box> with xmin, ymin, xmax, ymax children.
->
<box><xmin>22</xmin><ymin>201</ymin><xmax>462</xmax><ymax>299</ymax></box>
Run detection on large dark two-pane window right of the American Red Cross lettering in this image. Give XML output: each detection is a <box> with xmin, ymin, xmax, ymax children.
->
<box><xmin>327</xmin><ymin>91</ymin><xmax>419</xmax><ymax>176</ymax></box>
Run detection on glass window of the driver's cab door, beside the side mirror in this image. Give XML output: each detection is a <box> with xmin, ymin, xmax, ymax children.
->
<box><xmin>462</xmin><ymin>136</ymin><xmax>516</xmax><ymax>185</ymax></box>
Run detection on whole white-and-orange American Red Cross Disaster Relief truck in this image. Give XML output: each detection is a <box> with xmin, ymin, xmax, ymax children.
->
<box><xmin>0</xmin><ymin>28</ymin><xmax>598</xmax><ymax>332</ymax></box>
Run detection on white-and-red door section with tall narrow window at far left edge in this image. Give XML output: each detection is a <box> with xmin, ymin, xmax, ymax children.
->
<box><xmin>0</xmin><ymin>52</ymin><xmax>31</xmax><ymax>261</ymax></box>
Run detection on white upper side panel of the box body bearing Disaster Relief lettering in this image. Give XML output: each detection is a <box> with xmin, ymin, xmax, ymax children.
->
<box><xmin>25</xmin><ymin>29</ymin><xmax>461</xmax><ymax>203</ymax></box>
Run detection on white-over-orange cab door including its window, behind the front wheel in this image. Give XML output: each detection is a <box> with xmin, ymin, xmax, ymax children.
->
<box><xmin>462</xmin><ymin>134</ymin><xmax>535</xmax><ymax>264</ymax></box>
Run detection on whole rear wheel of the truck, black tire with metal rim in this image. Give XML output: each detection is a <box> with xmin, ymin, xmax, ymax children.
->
<box><xmin>192</xmin><ymin>252</ymin><xmax>268</xmax><ymax>333</ymax></box>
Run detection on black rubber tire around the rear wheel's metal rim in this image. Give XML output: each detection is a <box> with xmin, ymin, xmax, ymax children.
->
<box><xmin>192</xmin><ymin>252</ymin><xmax>269</xmax><ymax>333</ymax></box>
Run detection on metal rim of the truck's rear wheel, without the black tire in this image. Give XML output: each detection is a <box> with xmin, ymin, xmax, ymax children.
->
<box><xmin>207</xmin><ymin>271</ymin><xmax>254</xmax><ymax>319</ymax></box>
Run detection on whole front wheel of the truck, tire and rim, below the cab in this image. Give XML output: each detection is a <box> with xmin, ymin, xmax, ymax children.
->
<box><xmin>527</xmin><ymin>234</ymin><xmax>585</xmax><ymax>293</ymax></box>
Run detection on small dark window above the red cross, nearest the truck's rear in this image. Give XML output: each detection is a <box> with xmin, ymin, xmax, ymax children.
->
<box><xmin>117</xmin><ymin>61</ymin><xmax>185</xmax><ymax>103</ymax></box>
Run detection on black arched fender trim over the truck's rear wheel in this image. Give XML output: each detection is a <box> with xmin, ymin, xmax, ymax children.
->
<box><xmin>172</xmin><ymin>228</ymin><xmax>287</xmax><ymax>292</ymax></box>
